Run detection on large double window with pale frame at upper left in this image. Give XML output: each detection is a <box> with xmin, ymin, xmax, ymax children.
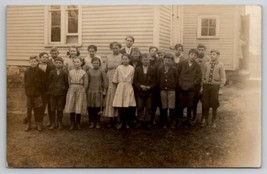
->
<box><xmin>45</xmin><ymin>5</ymin><xmax>81</xmax><ymax>46</ymax></box>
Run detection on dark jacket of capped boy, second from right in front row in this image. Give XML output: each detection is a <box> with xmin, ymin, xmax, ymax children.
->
<box><xmin>177</xmin><ymin>61</ymin><xmax>201</xmax><ymax>90</ymax></box>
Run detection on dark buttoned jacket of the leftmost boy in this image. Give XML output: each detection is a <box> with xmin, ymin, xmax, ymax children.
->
<box><xmin>24</xmin><ymin>67</ymin><xmax>45</xmax><ymax>97</ymax></box>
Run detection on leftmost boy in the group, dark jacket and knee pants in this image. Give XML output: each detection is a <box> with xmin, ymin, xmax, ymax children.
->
<box><xmin>24</xmin><ymin>56</ymin><xmax>45</xmax><ymax>131</ymax></box>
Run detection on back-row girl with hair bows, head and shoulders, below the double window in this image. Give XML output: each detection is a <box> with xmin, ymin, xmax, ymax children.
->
<box><xmin>64</xmin><ymin>46</ymin><xmax>84</xmax><ymax>71</ymax></box>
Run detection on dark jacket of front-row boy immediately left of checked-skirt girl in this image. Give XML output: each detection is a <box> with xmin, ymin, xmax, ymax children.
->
<box><xmin>48</xmin><ymin>69</ymin><xmax>69</xmax><ymax>96</ymax></box>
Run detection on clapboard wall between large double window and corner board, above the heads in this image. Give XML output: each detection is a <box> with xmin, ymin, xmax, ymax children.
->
<box><xmin>81</xmin><ymin>5</ymin><xmax>154</xmax><ymax>57</ymax></box>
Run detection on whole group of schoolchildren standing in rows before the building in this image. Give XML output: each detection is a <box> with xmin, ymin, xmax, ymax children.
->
<box><xmin>25</xmin><ymin>36</ymin><xmax>226</xmax><ymax>131</ymax></box>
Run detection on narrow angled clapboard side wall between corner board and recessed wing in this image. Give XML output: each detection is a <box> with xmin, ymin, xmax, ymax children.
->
<box><xmin>159</xmin><ymin>5</ymin><xmax>172</xmax><ymax>51</ymax></box>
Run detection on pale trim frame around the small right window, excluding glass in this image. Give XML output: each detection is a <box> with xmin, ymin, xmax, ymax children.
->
<box><xmin>197</xmin><ymin>15</ymin><xmax>220</xmax><ymax>39</ymax></box>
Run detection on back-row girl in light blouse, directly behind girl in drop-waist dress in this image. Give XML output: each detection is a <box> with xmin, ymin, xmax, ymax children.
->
<box><xmin>83</xmin><ymin>45</ymin><xmax>103</xmax><ymax>72</ymax></box>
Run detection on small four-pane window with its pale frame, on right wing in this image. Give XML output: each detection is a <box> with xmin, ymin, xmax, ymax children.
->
<box><xmin>197</xmin><ymin>16</ymin><xmax>219</xmax><ymax>38</ymax></box>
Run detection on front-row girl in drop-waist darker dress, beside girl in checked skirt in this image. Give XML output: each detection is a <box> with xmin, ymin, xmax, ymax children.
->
<box><xmin>87</xmin><ymin>57</ymin><xmax>108</xmax><ymax>129</ymax></box>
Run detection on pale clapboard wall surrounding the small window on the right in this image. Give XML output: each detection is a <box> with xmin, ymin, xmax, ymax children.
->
<box><xmin>183</xmin><ymin>5</ymin><xmax>243</xmax><ymax>70</ymax></box>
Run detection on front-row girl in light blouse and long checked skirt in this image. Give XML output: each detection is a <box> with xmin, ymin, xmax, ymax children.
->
<box><xmin>65</xmin><ymin>57</ymin><xmax>88</xmax><ymax>130</ymax></box>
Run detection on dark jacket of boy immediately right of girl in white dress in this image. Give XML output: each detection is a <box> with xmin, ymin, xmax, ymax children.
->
<box><xmin>133</xmin><ymin>66</ymin><xmax>156</xmax><ymax>96</ymax></box>
